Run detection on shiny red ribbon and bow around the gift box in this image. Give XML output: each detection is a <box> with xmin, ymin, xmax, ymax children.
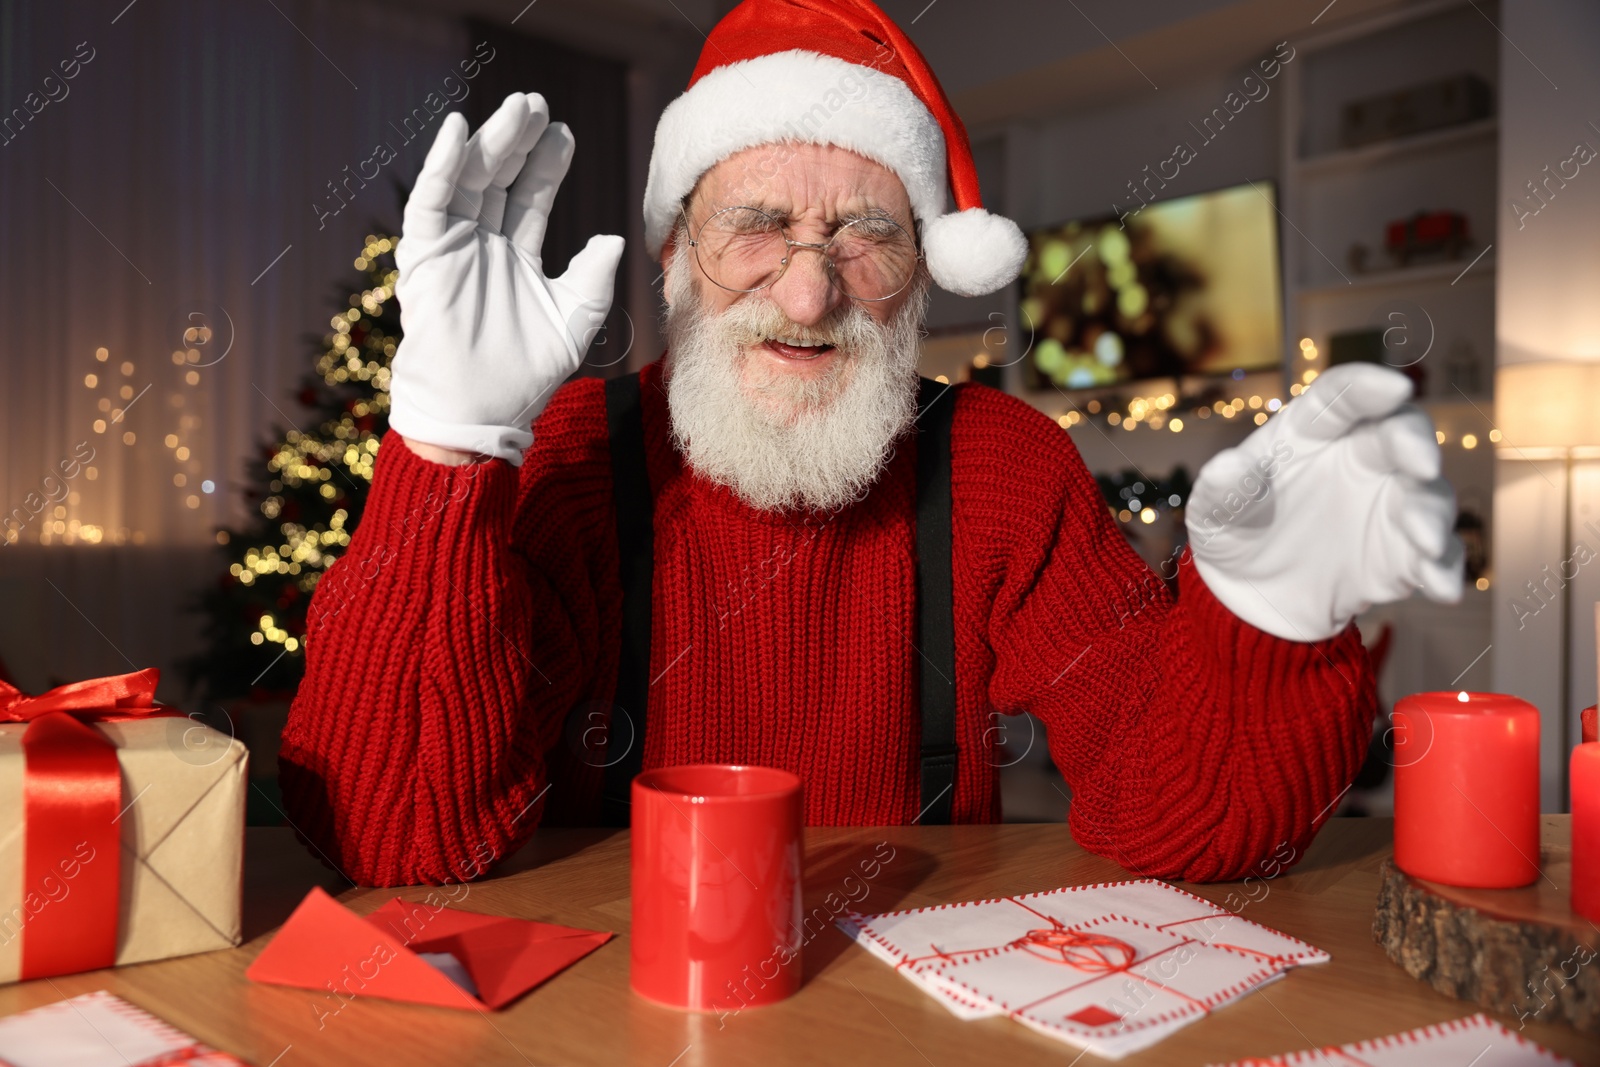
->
<box><xmin>0</xmin><ymin>667</ymin><xmax>170</xmax><ymax>979</ymax></box>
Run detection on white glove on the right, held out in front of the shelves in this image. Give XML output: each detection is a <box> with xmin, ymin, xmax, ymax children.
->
<box><xmin>1187</xmin><ymin>363</ymin><xmax>1464</xmax><ymax>641</ymax></box>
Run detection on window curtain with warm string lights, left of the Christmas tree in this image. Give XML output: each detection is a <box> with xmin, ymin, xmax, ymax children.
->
<box><xmin>0</xmin><ymin>0</ymin><xmax>626</xmax><ymax>702</ymax></box>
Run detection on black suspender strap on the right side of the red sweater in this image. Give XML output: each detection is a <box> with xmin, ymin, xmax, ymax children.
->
<box><xmin>917</xmin><ymin>378</ymin><xmax>955</xmax><ymax>825</ymax></box>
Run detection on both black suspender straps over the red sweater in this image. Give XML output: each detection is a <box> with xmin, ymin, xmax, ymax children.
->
<box><xmin>602</xmin><ymin>374</ymin><xmax>955</xmax><ymax>825</ymax></box>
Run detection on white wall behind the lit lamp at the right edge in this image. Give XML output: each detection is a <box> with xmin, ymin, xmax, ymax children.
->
<box><xmin>1493</xmin><ymin>0</ymin><xmax>1600</xmax><ymax>811</ymax></box>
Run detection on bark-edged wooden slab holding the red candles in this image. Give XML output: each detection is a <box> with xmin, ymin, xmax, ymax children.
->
<box><xmin>1373</xmin><ymin>816</ymin><xmax>1600</xmax><ymax>1033</ymax></box>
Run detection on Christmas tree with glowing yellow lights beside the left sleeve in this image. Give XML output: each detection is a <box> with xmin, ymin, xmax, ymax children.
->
<box><xmin>184</xmin><ymin>234</ymin><xmax>400</xmax><ymax>701</ymax></box>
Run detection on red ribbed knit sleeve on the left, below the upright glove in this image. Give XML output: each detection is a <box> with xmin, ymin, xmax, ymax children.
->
<box><xmin>280</xmin><ymin>382</ymin><xmax>614</xmax><ymax>886</ymax></box>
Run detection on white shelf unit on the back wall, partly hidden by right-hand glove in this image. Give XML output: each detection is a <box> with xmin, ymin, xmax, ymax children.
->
<box><xmin>1278</xmin><ymin>0</ymin><xmax>1499</xmax><ymax>751</ymax></box>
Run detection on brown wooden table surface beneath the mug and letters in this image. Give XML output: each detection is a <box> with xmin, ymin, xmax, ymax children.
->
<box><xmin>0</xmin><ymin>816</ymin><xmax>1600</xmax><ymax>1067</ymax></box>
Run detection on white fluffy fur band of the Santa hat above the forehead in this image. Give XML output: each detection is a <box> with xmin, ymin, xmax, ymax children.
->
<box><xmin>645</xmin><ymin>48</ymin><xmax>950</xmax><ymax>254</ymax></box>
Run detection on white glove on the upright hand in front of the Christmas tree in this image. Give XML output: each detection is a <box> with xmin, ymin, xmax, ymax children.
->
<box><xmin>389</xmin><ymin>93</ymin><xmax>622</xmax><ymax>466</ymax></box>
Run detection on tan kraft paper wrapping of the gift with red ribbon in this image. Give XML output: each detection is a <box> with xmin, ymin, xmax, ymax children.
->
<box><xmin>0</xmin><ymin>717</ymin><xmax>248</xmax><ymax>982</ymax></box>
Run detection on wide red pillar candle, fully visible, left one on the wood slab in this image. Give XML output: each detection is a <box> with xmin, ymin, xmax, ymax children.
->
<box><xmin>1394</xmin><ymin>693</ymin><xmax>1539</xmax><ymax>889</ymax></box>
